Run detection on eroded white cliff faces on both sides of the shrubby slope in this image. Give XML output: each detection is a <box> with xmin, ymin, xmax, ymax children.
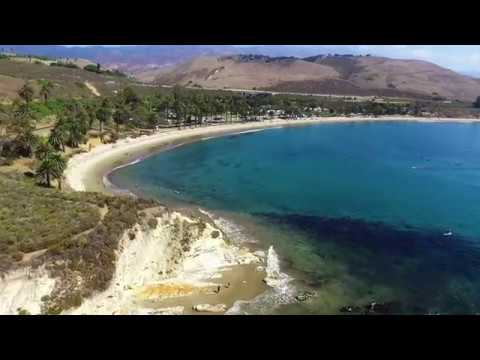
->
<box><xmin>0</xmin><ymin>211</ymin><xmax>264</xmax><ymax>314</ymax></box>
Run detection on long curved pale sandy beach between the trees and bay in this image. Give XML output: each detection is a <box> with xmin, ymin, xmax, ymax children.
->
<box><xmin>65</xmin><ymin>116</ymin><xmax>480</xmax><ymax>195</ymax></box>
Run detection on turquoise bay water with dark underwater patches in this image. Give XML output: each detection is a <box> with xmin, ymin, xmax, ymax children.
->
<box><xmin>111</xmin><ymin>122</ymin><xmax>480</xmax><ymax>313</ymax></box>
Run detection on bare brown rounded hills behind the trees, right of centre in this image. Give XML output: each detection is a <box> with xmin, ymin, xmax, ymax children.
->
<box><xmin>154</xmin><ymin>55</ymin><xmax>480</xmax><ymax>102</ymax></box>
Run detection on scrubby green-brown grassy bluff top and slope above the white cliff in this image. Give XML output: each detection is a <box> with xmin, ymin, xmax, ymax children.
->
<box><xmin>0</xmin><ymin>174</ymin><xmax>158</xmax><ymax>314</ymax></box>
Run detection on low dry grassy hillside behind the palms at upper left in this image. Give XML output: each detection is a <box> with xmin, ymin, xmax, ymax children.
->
<box><xmin>0</xmin><ymin>58</ymin><xmax>130</xmax><ymax>102</ymax></box>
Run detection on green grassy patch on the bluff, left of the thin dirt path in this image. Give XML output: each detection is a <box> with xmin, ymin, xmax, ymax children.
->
<box><xmin>0</xmin><ymin>175</ymin><xmax>100</xmax><ymax>266</ymax></box>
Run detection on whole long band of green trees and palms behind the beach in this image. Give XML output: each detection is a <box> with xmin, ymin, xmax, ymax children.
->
<box><xmin>0</xmin><ymin>80</ymin><xmax>480</xmax><ymax>190</ymax></box>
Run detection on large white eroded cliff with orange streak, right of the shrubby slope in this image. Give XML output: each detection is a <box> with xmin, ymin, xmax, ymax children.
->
<box><xmin>64</xmin><ymin>211</ymin><xmax>261</xmax><ymax>314</ymax></box>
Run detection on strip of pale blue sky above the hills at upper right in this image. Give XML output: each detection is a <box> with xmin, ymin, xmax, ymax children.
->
<box><xmin>64</xmin><ymin>45</ymin><xmax>480</xmax><ymax>77</ymax></box>
